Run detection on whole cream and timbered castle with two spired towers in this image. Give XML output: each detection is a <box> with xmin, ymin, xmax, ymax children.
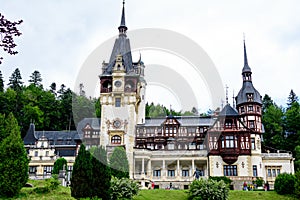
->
<box><xmin>24</xmin><ymin>1</ymin><xmax>294</xmax><ymax>189</ymax></box>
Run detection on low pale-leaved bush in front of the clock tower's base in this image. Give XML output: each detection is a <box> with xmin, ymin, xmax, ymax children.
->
<box><xmin>110</xmin><ymin>177</ymin><xmax>140</xmax><ymax>200</ymax></box>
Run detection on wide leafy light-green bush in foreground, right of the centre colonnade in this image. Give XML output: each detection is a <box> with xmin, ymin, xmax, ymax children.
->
<box><xmin>188</xmin><ymin>179</ymin><xmax>229</xmax><ymax>200</ymax></box>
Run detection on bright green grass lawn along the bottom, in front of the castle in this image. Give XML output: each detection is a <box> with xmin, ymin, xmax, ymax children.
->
<box><xmin>0</xmin><ymin>180</ymin><xmax>295</xmax><ymax>200</ymax></box>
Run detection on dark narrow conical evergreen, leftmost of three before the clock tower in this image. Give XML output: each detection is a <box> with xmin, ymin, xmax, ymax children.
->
<box><xmin>71</xmin><ymin>144</ymin><xmax>94</xmax><ymax>199</ymax></box>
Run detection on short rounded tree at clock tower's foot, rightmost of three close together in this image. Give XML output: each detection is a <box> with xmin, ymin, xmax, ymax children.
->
<box><xmin>109</xmin><ymin>146</ymin><xmax>129</xmax><ymax>178</ymax></box>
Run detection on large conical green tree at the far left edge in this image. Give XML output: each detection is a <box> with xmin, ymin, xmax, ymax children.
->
<box><xmin>0</xmin><ymin>113</ymin><xmax>29</xmax><ymax>197</ymax></box>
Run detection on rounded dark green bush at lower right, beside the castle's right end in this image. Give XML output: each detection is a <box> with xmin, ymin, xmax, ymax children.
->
<box><xmin>274</xmin><ymin>173</ymin><xmax>296</xmax><ymax>194</ymax></box>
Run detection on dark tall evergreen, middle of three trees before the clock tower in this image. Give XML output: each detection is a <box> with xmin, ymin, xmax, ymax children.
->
<box><xmin>91</xmin><ymin>146</ymin><xmax>111</xmax><ymax>200</ymax></box>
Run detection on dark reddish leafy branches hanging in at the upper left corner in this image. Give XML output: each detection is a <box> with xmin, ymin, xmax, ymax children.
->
<box><xmin>0</xmin><ymin>13</ymin><xmax>23</xmax><ymax>64</ymax></box>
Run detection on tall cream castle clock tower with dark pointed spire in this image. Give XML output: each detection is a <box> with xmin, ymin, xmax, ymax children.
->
<box><xmin>99</xmin><ymin>2</ymin><xmax>146</xmax><ymax>176</ymax></box>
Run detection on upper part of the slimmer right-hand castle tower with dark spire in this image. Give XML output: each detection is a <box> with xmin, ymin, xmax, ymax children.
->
<box><xmin>236</xmin><ymin>40</ymin><xmax>262</xmax><ymax>133</ymax></box>
